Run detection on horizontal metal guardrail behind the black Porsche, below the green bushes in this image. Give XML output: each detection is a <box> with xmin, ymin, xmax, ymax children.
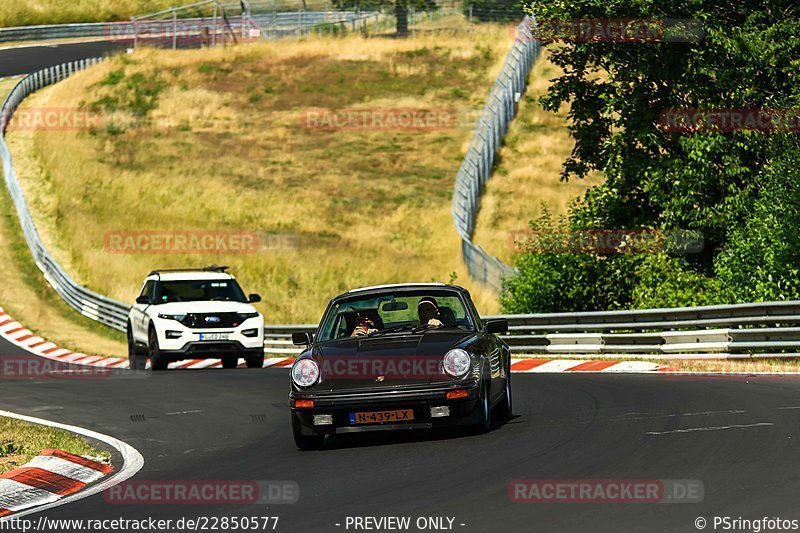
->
<box><xmin>265</xmin><ymin>301</ymin><xmax>800</xmax><ymax>359</ymax></box>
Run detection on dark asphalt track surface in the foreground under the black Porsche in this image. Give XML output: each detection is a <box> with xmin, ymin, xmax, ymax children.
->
<box><xmin>0</xmin><ymin>330</ymin><xmax>800</xmax><ymax>531</ymax></box>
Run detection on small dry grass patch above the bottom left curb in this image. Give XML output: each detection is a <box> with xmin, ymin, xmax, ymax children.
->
<box><xmin>0</xmin><ymin>417</ymin><xmax>111</xmax><ymax>473</ymax></box>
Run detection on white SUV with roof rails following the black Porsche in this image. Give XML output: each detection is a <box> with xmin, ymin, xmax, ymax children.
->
<box><xmin>128</xmin><ymin>267</ymin><xmax>264</xmax><ymax>370</ymax></box>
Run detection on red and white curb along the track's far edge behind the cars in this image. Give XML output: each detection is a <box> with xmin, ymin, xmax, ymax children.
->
<box><xmin>0</xmin><ymin>308</ymin><xmax>669</xmax><ymax>373</ymax></box>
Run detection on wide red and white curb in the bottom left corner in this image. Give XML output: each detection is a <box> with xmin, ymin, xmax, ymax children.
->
<box><xmin>0</xmin><ymin>449</ymin><xmax>114</xmax><ymax>516</ymax></box>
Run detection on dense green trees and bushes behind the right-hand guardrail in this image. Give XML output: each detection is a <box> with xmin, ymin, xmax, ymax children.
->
<box><xmin>503</xmin><ymin>0</ymin><xmax>800</xmax><ymax>312</ymax></box>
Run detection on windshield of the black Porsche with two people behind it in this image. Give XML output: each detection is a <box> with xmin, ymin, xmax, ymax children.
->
<box><xmin>317</xmin><ymin>290</ymin><xmax>473</xmax><ymax>342</ymax></box>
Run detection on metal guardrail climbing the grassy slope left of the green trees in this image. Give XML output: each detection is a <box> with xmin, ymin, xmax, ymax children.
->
<box><xmin>453</xmin><ymin>17</ymin><xmax>541</xmax><ymax>290</ymax></box>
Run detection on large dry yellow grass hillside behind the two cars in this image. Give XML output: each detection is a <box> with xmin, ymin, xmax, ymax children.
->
<box><xmin>9</xmin><ymin>26</ymin><xmax>511</xmax><ymax>323</ymax></box>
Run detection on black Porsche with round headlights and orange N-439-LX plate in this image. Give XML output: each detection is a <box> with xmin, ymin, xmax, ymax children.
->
<box><xmin>289</xmin><ymin>283</ymin><xmax>511</xmax><ymax>450</ymax></box>
